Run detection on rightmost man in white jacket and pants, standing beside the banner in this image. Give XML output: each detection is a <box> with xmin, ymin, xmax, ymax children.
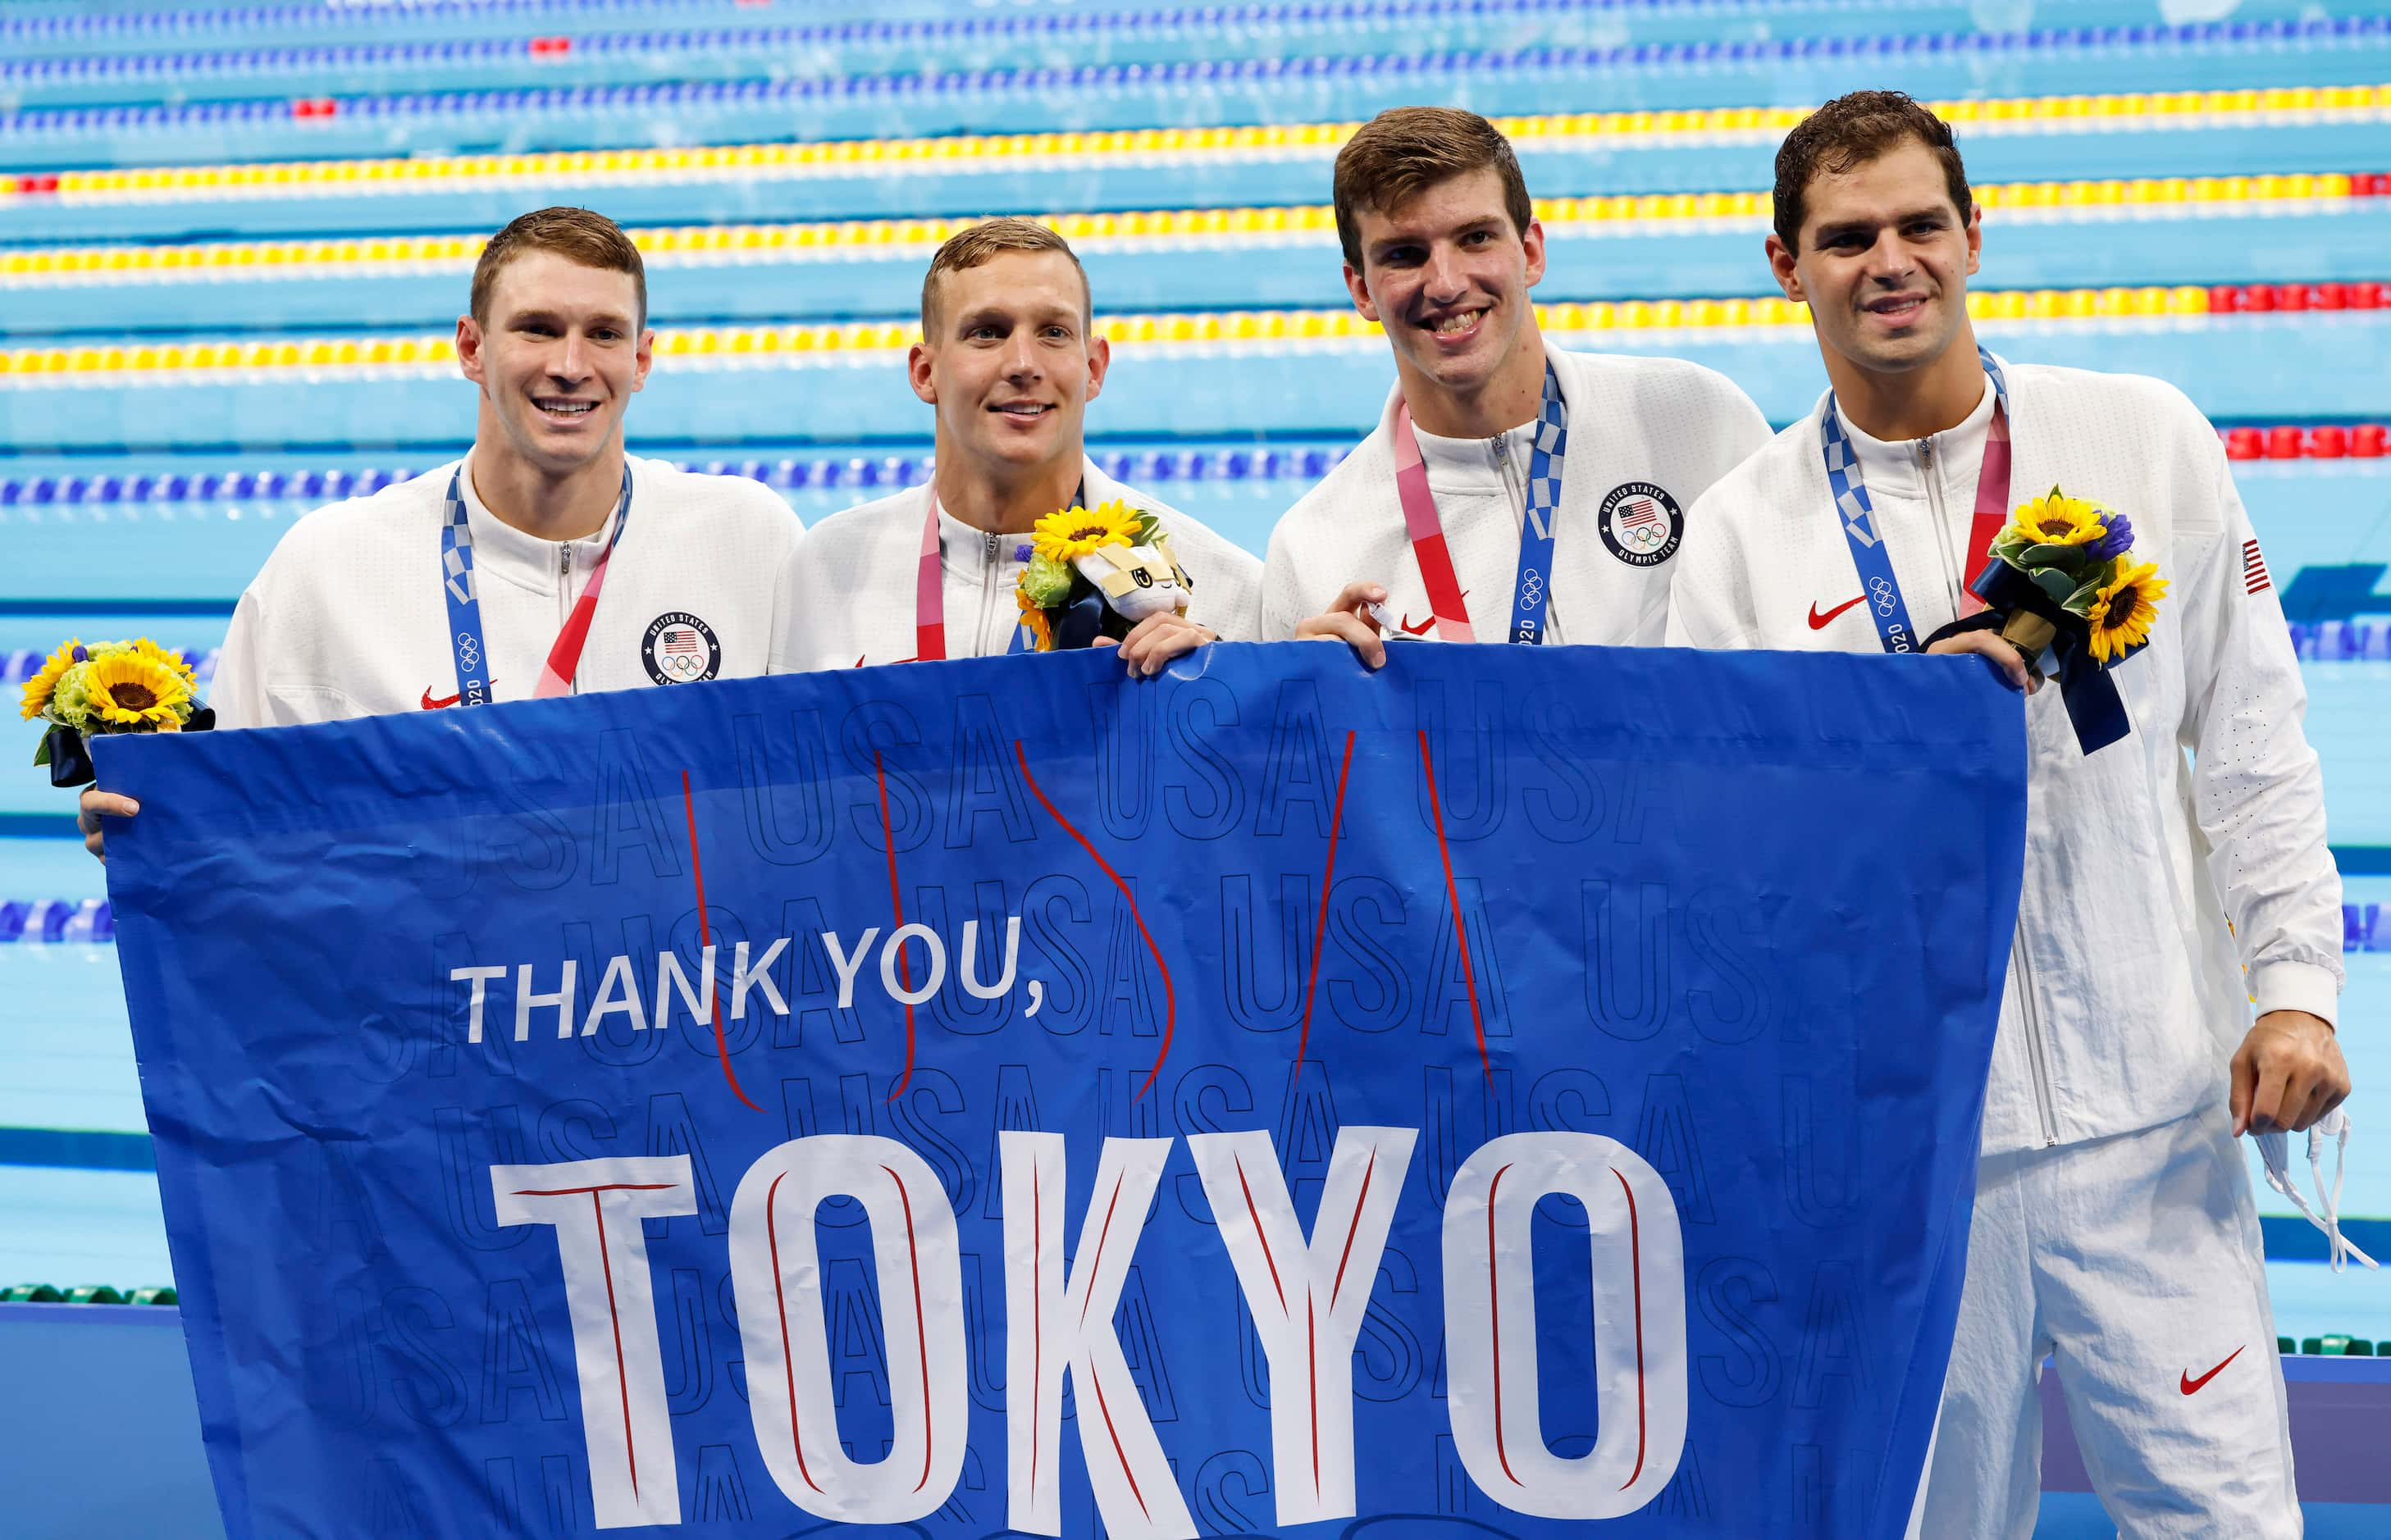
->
<box><xmin>1669</xmin><ymin>91</ymin><xmax>2350</xmax><ymax>1538</ymax></box>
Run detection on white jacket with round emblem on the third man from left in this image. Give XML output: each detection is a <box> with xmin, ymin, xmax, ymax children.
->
<box><xmin>1262</xmin><ymin>342</ymin><xmax>1769</xmax><ymax>645</ymax></box>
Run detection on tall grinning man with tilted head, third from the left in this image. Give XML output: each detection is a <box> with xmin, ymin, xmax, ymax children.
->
<box><xmin>1262</xmin><ymin>107</ymin><xmax>1769</xmax><ymax>667</ymax></box>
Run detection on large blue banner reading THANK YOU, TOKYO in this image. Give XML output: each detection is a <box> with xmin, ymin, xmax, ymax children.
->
<box><xmin>98</xmin><ymin>643</ymin><xmax>2025</xmax><ymax>1540</ymax></box>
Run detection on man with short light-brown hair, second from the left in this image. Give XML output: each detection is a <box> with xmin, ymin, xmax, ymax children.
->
<box><xmin>773</xmin><ymin>217</ymin><xmax>1262</xmax><ymax>674</ymax></box>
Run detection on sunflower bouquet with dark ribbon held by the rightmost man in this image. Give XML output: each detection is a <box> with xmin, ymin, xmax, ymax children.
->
<box><xmin>1970</xmin><ymin>488</ymin><xmax>2166</xmax><ymax>754</ymax></box>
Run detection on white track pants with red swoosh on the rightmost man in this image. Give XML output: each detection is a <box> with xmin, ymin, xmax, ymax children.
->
<box><xmin>1915</xmin><ymin>1107</ymin><xmax>2300</xmax><ymax>1540</ymax></box>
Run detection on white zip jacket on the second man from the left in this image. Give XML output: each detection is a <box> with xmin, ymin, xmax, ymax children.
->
<box><xmin>773</xmin><ymin>459</ymin><xmax>1262</xmax><ymax>674</ymax></box>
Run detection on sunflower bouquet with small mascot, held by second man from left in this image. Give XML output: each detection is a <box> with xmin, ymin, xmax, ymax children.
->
<box><xmin>1014</xmin><ymin>502</ymin><xmax>1193</xmax><ymax>653</ymax></box>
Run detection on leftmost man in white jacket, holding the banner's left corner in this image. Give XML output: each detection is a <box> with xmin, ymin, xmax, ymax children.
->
<box><xmin>81</xmin><ymin>208</ymin><xmax>801</xmax><ymax>854</ymax></box>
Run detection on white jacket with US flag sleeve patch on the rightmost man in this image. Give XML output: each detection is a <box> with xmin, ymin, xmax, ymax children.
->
<box><xmin>1669</xmin><ymin>361</ymin><xmax>2341</xmax><ymax>1153</ymax></box>
